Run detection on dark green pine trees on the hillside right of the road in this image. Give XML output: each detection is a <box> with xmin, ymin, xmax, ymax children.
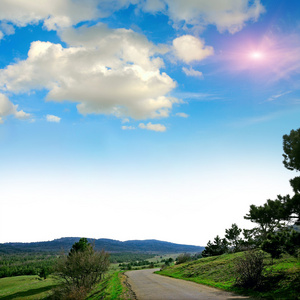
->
<box><xmin>202</xmin><ymin>128</ymin><xmax>300</xmax><ymax>258</ymax></box>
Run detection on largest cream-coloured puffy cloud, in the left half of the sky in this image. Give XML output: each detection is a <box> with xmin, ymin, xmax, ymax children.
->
<box><xmin>0</xmin><ymin>24</ymin><xmax>178</xmax><ymax>119</ymax></box>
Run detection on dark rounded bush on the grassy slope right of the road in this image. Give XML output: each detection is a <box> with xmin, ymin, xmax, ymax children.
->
<box><xmin>235</xmin><ymin>250</ymin><xmax>264</xmax><ymax>288</ymax></box>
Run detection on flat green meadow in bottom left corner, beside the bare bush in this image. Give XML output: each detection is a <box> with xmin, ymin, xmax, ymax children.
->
<box><xmin>0</xmin><ymin>275</ymin><xmax>56</xmax><ymax>300</ymax></box>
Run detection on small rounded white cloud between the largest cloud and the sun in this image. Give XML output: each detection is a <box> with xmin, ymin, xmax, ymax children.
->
<box><xmin>173</xmin><ymin>35</ymin><xmax>214</xmax><ymax>63</ymax></box>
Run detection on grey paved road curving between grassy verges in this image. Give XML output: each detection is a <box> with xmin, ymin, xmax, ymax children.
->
<box><xmin>126</xmin><ymin>269</ymin><xmax>249</xmax><ymax>300</ymax></box>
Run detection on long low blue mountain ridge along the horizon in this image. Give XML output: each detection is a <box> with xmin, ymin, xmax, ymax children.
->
<box><xmin>0</xmin><ymin>237</ymin><xmax>204</xmax><ymax>253</ymax></box>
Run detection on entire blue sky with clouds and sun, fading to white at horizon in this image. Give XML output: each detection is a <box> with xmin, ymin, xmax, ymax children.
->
<box><xmin>0</xmin><ymin>0</ymin><xmax>300</xmax><ymax>246</ymax></box>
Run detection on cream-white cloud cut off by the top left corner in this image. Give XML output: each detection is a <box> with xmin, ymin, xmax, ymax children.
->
<box><xmin>0</xmin><ymin>0</ymin><xmax>138</xmax><ymax>30</ymax></box>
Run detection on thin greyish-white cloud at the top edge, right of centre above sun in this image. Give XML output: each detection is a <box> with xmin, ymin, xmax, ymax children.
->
<box><xmin>141</xmin><ymin>0</ymin><xmax>265</xmax><ymax>33</ymax></box>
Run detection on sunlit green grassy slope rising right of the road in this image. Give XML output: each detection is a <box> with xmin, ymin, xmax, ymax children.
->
<box><xmin>157</xmin><ymin>252</ymin><xmax>300</xmax><ymax>299</ymax></box>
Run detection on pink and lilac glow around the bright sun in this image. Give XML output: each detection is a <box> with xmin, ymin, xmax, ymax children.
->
<box><xmin>220</xmin><ymin>34</ymin><xmax>300</xmax><ymax>81</ymax></box>
